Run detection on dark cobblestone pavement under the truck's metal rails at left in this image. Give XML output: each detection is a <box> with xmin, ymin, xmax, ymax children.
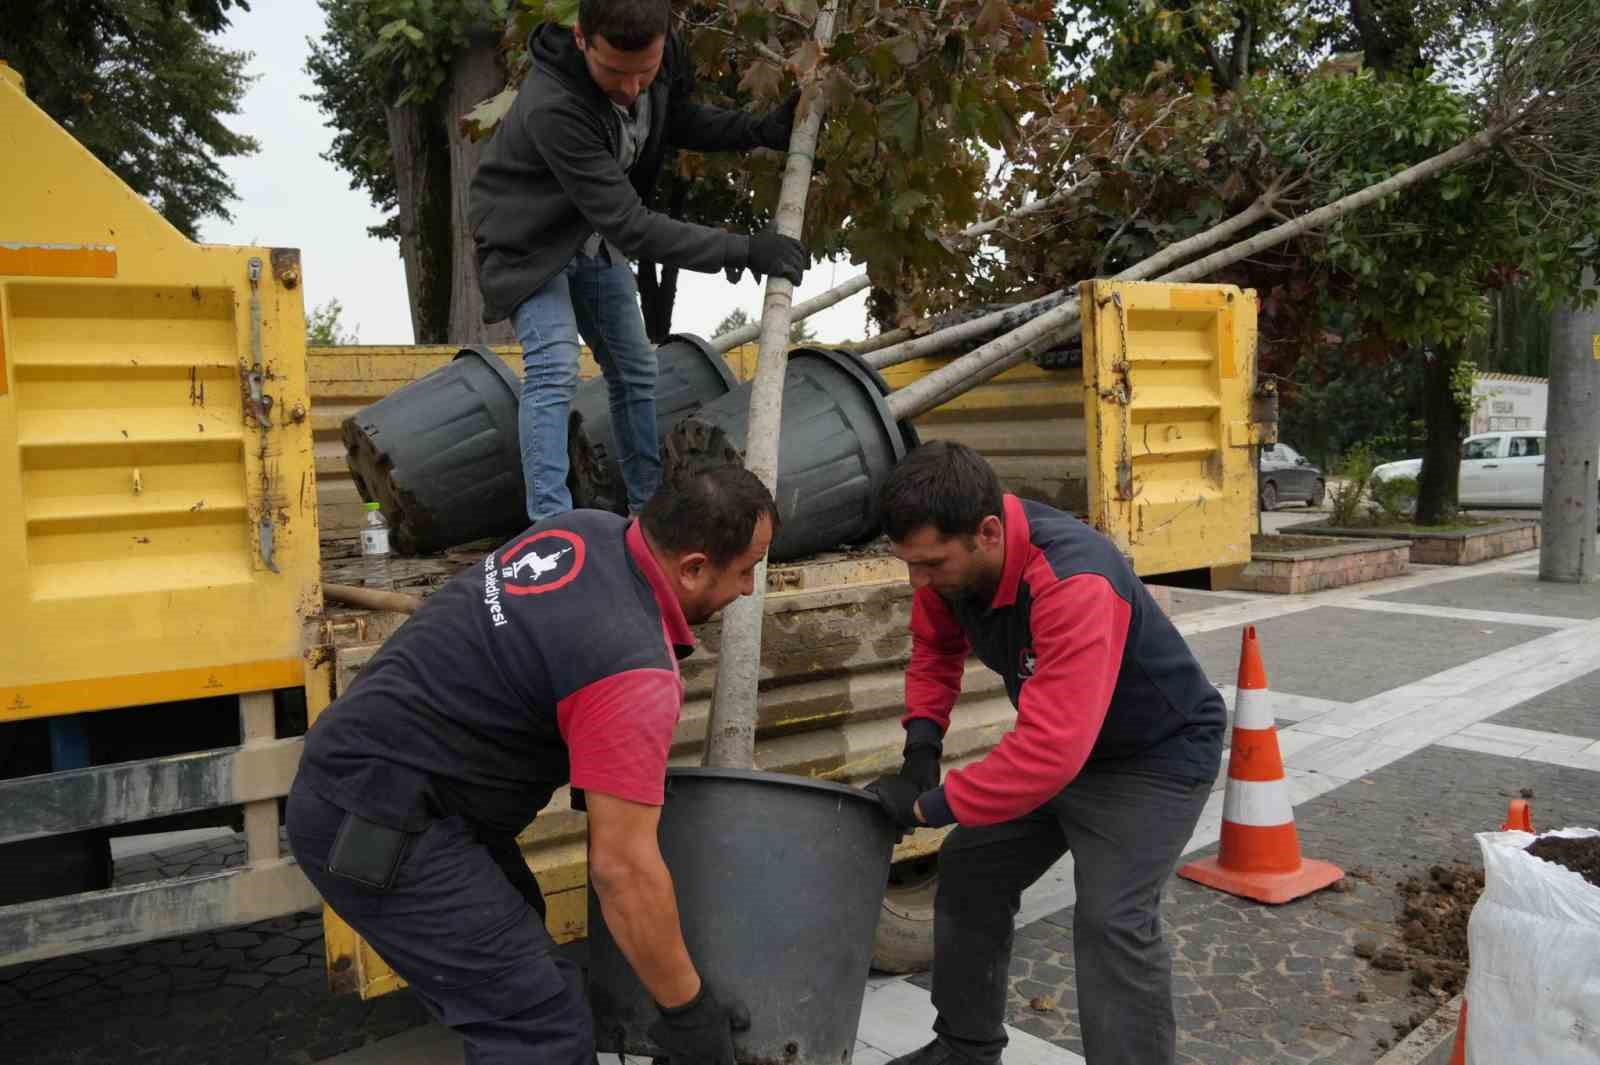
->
<box><xmin>0</xmin><ymin>838</ymin><xmax>429</xmax><ymax>1065</ymax></box>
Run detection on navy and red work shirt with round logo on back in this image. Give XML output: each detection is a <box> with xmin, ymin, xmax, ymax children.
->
<box><xmin>301</xmin><ymin>510</ymin><xmax>694</xmax><ymax>833</ymax></box>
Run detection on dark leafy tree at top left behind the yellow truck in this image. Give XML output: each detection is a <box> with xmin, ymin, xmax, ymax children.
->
<box><xmin>0</xmin><ymin>0</ymin><xmax>258</xmax><ymax>238</ymax></box>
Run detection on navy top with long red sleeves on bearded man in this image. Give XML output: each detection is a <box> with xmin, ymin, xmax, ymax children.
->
<box><xmin>904</xmin><ymin>496</ymin><xmax>1224</xmax><ymax>825</ymax></box>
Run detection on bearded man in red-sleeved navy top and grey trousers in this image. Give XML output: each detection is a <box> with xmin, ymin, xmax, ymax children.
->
<box><xmin>870</xmin><ymin>441</ymin><xmax>1224</xmax><ymax>1065</ymax></box>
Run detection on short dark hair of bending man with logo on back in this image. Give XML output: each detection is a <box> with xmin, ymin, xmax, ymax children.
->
<box><xmin>640</xmin><ymin>465</ymin><xmax>779</xmax><ymax>566</ymax></box>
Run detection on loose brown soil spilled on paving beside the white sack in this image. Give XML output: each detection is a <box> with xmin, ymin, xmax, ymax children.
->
<box><xmin>1355</xmin><ymin>864</ymin><xmax>1483</xmax><ymax>999</ymax></box>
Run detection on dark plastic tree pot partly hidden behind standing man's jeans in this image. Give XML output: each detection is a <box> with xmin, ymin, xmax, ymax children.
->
<box><xmin>566</xmin><ymin>333</ymin><xmax>739</xmax><ymax>513</ymax></box>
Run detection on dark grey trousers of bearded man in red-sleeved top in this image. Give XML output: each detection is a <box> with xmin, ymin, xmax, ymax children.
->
<box><xmin>933</xmin><ymin>768</ymin><xmax>1211</xmax><ymax>1065</ymax></box>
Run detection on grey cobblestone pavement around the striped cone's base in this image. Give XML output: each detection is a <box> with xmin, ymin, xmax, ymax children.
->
<box><xmin>915</xmin><ymin>747</ymin><xmax>1600</xmax><ymax>1065</ymax></box>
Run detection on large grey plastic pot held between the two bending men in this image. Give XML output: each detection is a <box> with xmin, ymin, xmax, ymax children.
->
<box><xmin>589</xmin><ymin>769</ymin><xmax>896</xmax><ymax>1065</ymax></box>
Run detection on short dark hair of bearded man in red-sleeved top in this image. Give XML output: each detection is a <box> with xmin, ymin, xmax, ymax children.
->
<box><xmin>878</xmin><ymin>440</ymin><xmax>1005</xmax><ymax>540</ymax></box>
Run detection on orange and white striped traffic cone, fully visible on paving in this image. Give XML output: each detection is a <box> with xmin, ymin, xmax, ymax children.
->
<box><xmin>1178</xmin><ymin>625</ymin><xmax>1344</xmax><ymax>903</ymax></box>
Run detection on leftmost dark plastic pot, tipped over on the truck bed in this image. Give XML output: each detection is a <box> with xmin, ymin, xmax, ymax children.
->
<box><xmin>342</xmin><ymin>347</ymin><xmax>528</xmax><ymax>555</ymax></box>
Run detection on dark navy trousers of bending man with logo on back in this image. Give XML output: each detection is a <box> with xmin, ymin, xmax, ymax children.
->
<box><xmin>288</xmin><ymin>782</ymin><xmax>595</xmax><ymax>1065</ymax></box>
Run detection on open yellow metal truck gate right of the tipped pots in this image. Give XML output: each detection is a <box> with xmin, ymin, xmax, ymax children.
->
<box><xmin>1080</xmin><ymin>281</ymin><xmax>1258</xmax><ymax>574</ymax></box>
